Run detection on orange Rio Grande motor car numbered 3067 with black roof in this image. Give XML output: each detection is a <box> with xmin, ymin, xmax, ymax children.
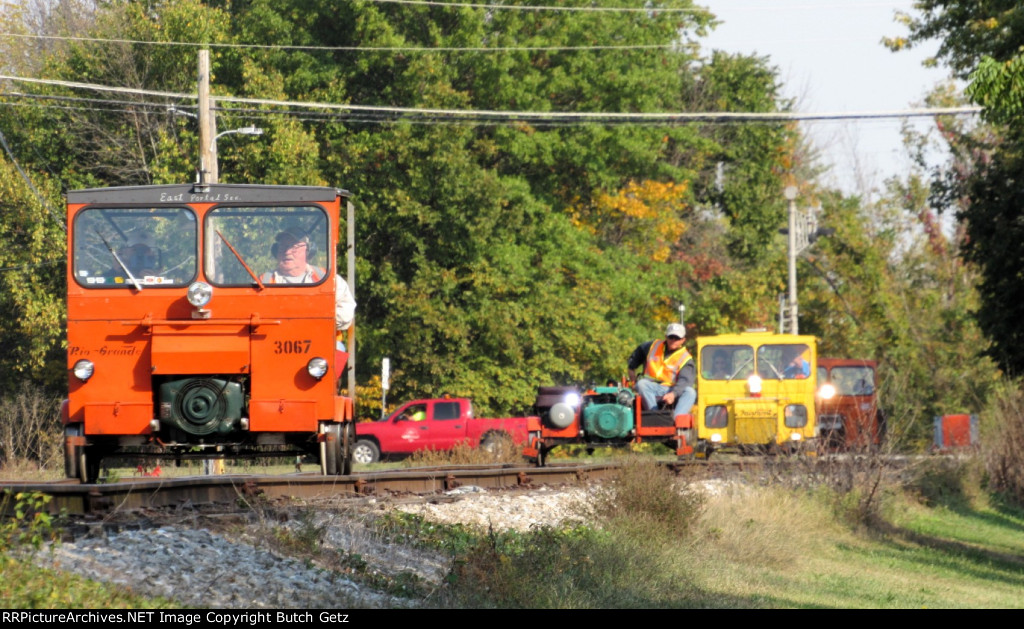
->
<box><xmin>61</xmin><ymin>183</ymin><xmax>355</xmax><ymax>483</ymax></box>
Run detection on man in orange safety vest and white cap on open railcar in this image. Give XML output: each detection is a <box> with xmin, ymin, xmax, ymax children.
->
<box><xmin>628</xmin><ymin>324</ymin><xmax>697</xmax><ymax>415</ymax></box>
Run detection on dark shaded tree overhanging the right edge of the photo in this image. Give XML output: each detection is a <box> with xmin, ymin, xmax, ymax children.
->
<box><xmin>891</xmin><ymin>0</ymin><xmax>1024</xmax><ymax>374</ymax></box>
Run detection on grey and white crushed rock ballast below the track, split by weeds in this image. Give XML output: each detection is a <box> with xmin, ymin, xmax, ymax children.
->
<box><xmin>37</xmin><ymin>488</ymin><xmax>587</xmax><ymax>609</ymax></box>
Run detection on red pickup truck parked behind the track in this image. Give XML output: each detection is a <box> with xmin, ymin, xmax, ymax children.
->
<box><xmin>352</xmin><ymin>397</ymin><xmax>526</xmax><ymax>464</ymax></box>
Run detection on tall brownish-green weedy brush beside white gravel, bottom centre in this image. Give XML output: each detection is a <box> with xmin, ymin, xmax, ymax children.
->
<box><xmin>442</xmin><ymin>457</ymin><xmax>703</xmax><ymax>609</ymax></box>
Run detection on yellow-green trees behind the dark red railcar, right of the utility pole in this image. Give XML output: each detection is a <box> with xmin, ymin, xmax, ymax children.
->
<box><xmin>799</xmin><ymin>91</ymin><xmax>997</xmax><ymax>448</ymax></box>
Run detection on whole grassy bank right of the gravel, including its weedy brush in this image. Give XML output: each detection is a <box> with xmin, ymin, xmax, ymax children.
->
<box><xmin>432</xmin><ymin>462</ymin><xmax>1024</xmax><ymax>609</ymax></box>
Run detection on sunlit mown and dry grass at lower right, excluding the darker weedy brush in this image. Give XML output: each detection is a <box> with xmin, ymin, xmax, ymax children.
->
<box><xmin>686</xmin><ymin>473</ymin><xmax>1024</xmax><ymax>609</ymax></box>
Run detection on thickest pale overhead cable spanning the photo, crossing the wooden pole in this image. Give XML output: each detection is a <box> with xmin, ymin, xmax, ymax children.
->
<box><xmin>0</xmin><ymin>75</ymin><xmax>981</xmax><ymax>124</ymax></box>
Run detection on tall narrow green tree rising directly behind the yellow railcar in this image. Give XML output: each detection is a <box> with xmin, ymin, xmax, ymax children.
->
<box><xmin>677</xmin><ymin>51</ymin><xmax>804</xmax><ymax>334</ymax></box>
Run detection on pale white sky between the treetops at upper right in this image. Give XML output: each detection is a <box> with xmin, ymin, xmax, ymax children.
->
<box><xmin>696</xmin><ymin>0</ymin><xmax>948</xmax><ymax>194</ymax></box>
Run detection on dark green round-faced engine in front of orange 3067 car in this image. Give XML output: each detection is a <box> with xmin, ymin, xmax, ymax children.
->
<box><xmin>159</xmin><ymin>378</ymin><xmax>245</xmax><ymax>436</ymax></box>
